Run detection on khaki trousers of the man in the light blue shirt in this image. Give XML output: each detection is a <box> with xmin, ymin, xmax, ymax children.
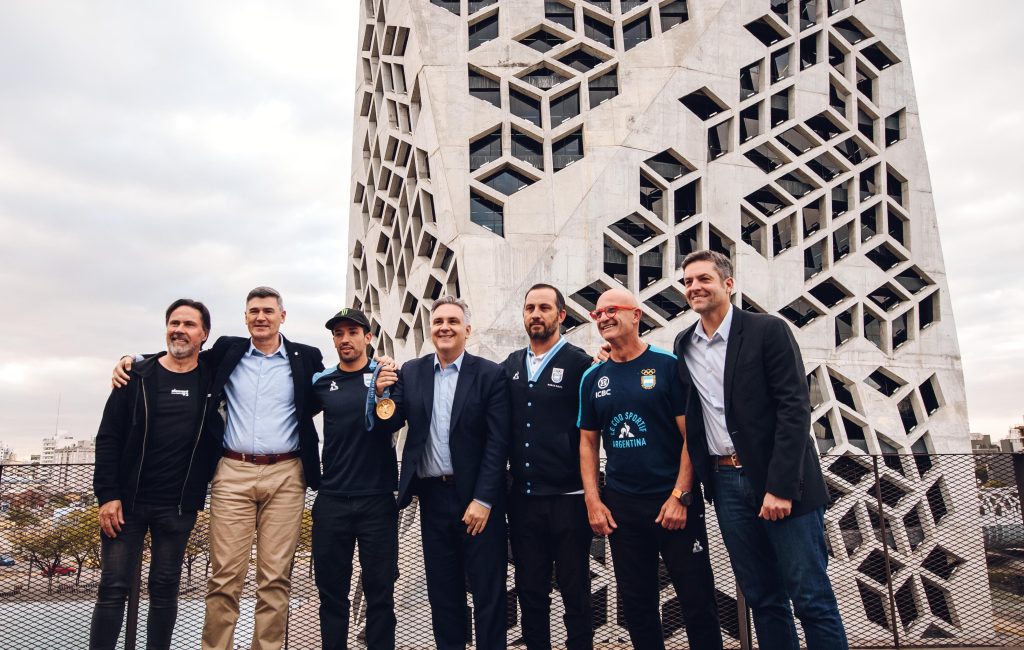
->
<box><xmin>203</xmin><ymin>458</ymin><xmax>306</xmax><ymax>650</ymax></box>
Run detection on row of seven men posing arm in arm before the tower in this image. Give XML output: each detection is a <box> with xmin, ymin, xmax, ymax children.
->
<box><xmin>90</xmin><ymin>251</ymin><xmax>846</xmax><ymax>650</ymax></box>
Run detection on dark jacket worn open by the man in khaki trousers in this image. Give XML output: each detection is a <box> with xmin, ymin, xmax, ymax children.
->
<box><xmin>202</xmin><ymin>335</ymin><xmax>324</xmax><ymax>489</ymax></box>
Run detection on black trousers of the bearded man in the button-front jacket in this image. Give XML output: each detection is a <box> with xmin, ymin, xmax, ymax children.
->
<box><xmin>509</xmin><ymin>493</ymin><xmax>594</xmax><ymax>650</ymax></box>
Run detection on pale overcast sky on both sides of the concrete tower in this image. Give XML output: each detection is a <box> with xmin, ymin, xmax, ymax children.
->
<box><xmin>0</xmin><ymin>0</ymin><xmax>1024</xmax><ymax>456</ymax></box>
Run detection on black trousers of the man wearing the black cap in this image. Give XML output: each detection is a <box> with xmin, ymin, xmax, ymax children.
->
<box><xmin>312</xmin><ymin>493</ymin><xmax>398</xmax><ymax>650</ymax></box>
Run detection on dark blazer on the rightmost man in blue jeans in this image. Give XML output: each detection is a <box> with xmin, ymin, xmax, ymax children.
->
<box><xmin>674</xmin><ymin>308</ymin><xmax>828</xmax><ymax>515</ymax></box>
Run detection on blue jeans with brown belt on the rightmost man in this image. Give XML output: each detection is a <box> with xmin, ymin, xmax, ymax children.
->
<box><xmin>712</xmin><ymin>467</ymin><xmax>848</xmax><ymax>650</ymax></box>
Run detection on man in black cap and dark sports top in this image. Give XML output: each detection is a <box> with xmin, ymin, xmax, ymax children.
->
<box><xmin>312</xmin><ymin>309</ymin><xmax>401</xmax><ymax>650</ymax></box>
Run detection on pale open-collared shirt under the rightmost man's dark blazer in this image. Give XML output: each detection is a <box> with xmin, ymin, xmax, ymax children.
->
<box><xmin>685</xmin><ymin>305</ymin><xmax>735</xmax><ymax>456</ymax></box>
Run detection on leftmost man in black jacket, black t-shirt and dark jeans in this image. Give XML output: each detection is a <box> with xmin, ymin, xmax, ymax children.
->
<box><xmin>89</xmin><ymin>298</ymin><xmax>223</xmax><ymax>650</ymax></box>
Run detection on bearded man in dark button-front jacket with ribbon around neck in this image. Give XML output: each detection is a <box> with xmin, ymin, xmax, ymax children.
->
<box><xmin>502</xmin><ymin>285</ymin><xmax>594</xmax><ymax>650</ymax></box>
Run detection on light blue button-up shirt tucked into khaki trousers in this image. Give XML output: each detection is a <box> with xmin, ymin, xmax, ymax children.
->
<box><xmin>224</xmin><ymin>341</ymin><xmax>299</xmax><ymax>453</ymax></box>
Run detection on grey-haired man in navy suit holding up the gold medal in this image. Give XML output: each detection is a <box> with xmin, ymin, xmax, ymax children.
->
<box><xmin>376</xmin><ymin>296</ymin><xmax>509</xmax><ymax>650</ymax></box>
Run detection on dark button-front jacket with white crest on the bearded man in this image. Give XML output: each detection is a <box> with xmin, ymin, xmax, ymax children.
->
<box><xmin>502</xmin><ymin>340</ymin><xmax>591</xmax><ymax>496</ymax></box>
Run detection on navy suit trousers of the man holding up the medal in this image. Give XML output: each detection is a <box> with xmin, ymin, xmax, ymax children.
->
<box><xmin>418</xmin><ymin>479</ymin><xmax>508</xmax><ymax>650</ymax></box>
